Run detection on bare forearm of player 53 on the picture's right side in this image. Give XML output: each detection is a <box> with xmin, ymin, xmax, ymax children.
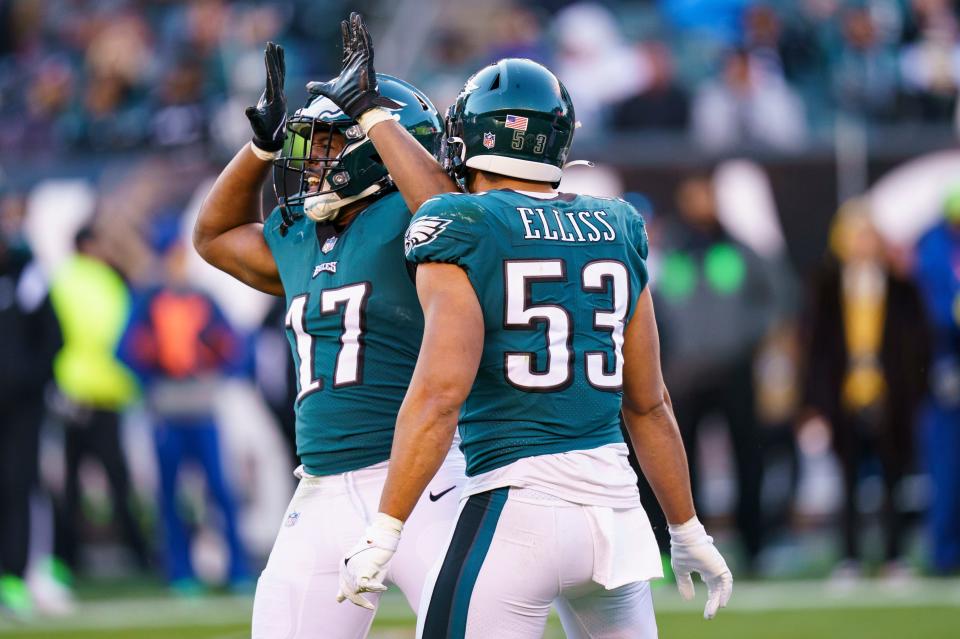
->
<box><xmin>623</xmin><ymin>390</ymin><xmax>696</xmax><ymax>524</ymax></box>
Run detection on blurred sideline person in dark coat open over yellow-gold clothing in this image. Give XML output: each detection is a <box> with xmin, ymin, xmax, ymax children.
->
<box><xmin>805</xmin><ymin>200</ymin><xmax>929</xmax><ymax>579</ymax></box>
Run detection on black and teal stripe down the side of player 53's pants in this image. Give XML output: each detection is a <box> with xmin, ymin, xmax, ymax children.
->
<box><xmin>422</xmin><ymin>487</ymin><xmax>510</xmax><ymax>639</ymax></box>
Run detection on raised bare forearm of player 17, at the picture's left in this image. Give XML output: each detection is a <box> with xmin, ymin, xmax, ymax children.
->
<box><xmin>193</xmin><ymin>144</ymin><xmax>271</xmax><ymax>256</ymax></box>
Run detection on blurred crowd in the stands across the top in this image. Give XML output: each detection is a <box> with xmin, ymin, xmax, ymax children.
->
<box><xmin>0</xmin><ymin>0</ymin><xmax>960</xmax><ymax>160</ymax></box>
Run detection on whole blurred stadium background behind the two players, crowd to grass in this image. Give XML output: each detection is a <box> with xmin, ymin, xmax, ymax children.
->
<box><xmin>0</xmin><ymin>0</ymin><xmax>960</xmax><ymax>638</ymax></box>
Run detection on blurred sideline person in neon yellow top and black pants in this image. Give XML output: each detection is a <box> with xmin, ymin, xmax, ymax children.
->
<box><xmin>50</xmin><ymin>226</ymin><xmax>150</xmax><ymax>570</ymax></box>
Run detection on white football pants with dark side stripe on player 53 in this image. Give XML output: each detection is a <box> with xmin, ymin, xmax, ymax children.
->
<box><xmin>417</xmin><ymin>487</ymin><xmax>657</xmax><ymax>639</ymax></box>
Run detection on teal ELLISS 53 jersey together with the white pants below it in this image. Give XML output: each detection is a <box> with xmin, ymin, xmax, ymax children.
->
<box><xmin>406</xmin><ymin>189</ymin><xmax>662</xmax><ymax>638</ymax></box>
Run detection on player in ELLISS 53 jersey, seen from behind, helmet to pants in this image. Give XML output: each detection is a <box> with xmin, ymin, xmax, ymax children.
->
<box><xmin>341</xmin><ymin>59</ymin><xmax>733</xmax><ymax>639</ymax></box>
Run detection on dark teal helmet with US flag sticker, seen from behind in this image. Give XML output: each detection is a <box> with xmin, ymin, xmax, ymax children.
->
<box><xmin>441</xmin><ymin>58</ymin><xmax>576</xmax><ymax>184</ymax></box>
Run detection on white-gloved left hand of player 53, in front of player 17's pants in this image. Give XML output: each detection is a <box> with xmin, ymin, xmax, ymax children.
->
<box><xmin>337</xmin><ymin>513</ymin><xmax>403</xmax><ymax>610</ymax></box>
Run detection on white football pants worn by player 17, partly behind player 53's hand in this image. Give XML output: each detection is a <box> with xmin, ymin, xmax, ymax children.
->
<box><xmin>253</xmin><ymin>448</ymin><xmax>464</xmax><ymax>639</ymax></box>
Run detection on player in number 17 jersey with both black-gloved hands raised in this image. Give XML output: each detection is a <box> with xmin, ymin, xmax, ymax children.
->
<box><xmin>194</xmin><ymin>18</ymin><xmax>463</xmax><ymax>639</ymax></box>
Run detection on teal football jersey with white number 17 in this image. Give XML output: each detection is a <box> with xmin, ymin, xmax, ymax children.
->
<box><xmin>264</xmin><ymin>193</ymin><xmax>423</xmax><ymax>475</ymax></box>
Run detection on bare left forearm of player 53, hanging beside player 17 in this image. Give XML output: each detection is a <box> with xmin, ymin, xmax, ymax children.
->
<box><xmin>380</xmin><ymin>399</ymin><xmax>459</xmax><ymax>521</ymax></box>
